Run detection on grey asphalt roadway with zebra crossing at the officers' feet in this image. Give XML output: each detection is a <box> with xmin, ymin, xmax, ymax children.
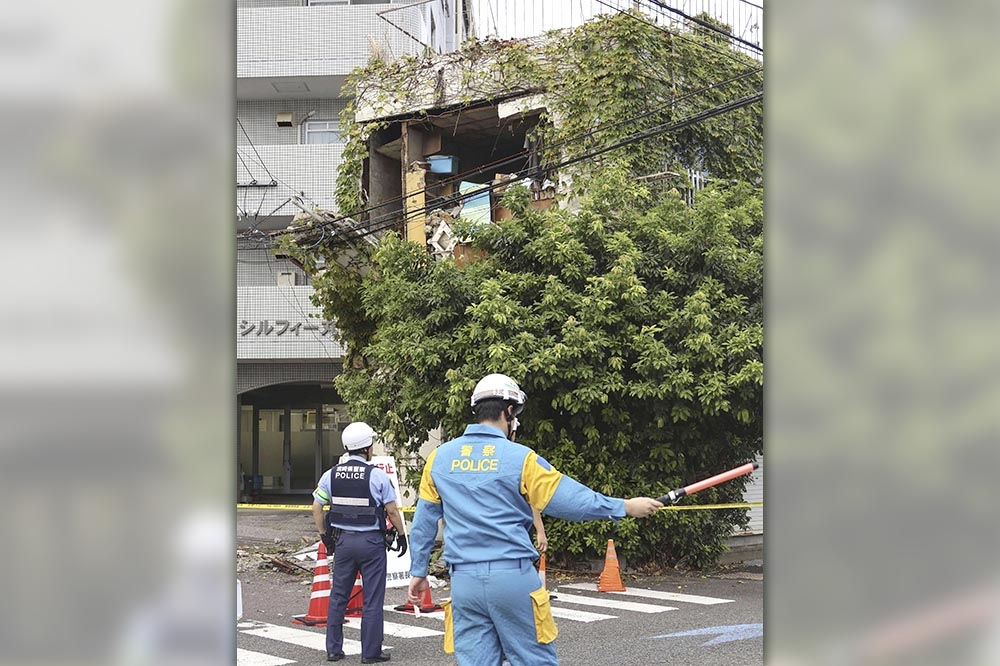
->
<box><xmin>237</xmin><ymin>572</ymin><xmax>764</xmax><ymax>666</ymax></box>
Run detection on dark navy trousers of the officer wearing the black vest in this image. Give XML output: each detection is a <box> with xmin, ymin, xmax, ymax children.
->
<box><xmin>326</xmin><ymin>530</ymin><xmax>386</xmax><ymax>658</ymax></box>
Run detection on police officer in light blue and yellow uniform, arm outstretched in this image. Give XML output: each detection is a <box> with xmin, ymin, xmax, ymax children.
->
<box><xmin>408</xmin><ymin>374</ymin><xmax>663</xmax><ymax>666</ymax></box>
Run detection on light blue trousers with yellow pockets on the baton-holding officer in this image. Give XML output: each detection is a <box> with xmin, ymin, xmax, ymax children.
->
<box><xmin>451</xmin><ymin>559</ymin><xmax>559</xmax><ymax>666</ymax></box>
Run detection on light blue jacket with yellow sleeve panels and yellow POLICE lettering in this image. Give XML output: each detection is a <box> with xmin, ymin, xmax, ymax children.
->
<box><xmin>410</xmin><ymin>424</ymin><xmax>625</xmax><ymax>576</ymax></box>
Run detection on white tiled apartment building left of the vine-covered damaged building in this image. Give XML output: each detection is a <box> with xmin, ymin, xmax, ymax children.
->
<box><xmin>234</xmin><ymin>0</ymin><xmax>471</xmax><ymax>499</ymax></box>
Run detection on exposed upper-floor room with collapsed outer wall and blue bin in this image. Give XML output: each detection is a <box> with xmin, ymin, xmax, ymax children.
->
<box><xmin>356</xmin><ymin>56</ymin><xmax>558</xmax><ymax>261</ymax></box>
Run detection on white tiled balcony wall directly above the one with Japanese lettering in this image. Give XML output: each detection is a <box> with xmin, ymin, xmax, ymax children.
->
<box><xmin>236</xmin><ymin>144</ymin><xmax>343</xmax><ymax>231</ymax></box>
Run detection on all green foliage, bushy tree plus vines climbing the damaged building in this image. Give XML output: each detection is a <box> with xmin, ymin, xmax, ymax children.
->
<box><xmin>282</xmin><ymin>10</ymin><xmax>763</xmax><ymax>566</ymax></box>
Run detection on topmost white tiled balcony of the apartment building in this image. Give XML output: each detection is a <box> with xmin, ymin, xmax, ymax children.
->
<box><xmin>236</xmin><ymin>3</ymin><xmax>428</xmax><ymax>100</ymax></box>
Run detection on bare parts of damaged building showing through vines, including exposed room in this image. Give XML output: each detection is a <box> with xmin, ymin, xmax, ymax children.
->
<box><xmin>340</xmin><ymin>31</ymin><xmax>748</xmax><ymax>260</ymax></box>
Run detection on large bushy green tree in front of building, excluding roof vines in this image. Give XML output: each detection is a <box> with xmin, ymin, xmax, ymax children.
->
<box><xmin>312</xmin><ymin>169</ymin><xmax>763</xmax><ymax>565</ymax></box>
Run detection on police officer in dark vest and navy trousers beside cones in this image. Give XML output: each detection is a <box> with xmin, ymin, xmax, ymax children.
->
<box><xmin>312</xmin><ymin>421</ymin><xmax>406</xmax><ymax>664</ymax></box>
